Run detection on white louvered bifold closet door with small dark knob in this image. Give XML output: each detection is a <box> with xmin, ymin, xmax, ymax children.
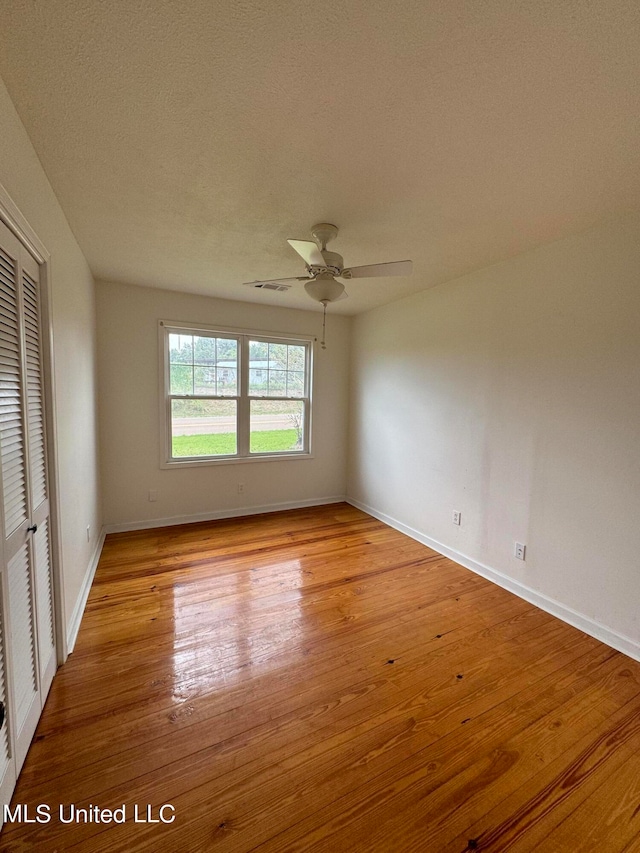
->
<box><xmin>0</xmin><ymin>216</ymin><xmax>56</xmax><ymax>775</ymax></box>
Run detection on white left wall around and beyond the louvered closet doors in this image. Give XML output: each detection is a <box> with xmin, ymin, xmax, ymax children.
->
<box><xmin>0</xmin><ymin>76</ymin><xmax>102</xmax><ymax>644</ymax></box>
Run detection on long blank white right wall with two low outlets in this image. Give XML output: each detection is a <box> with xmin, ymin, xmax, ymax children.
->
<box><xmin>348</xmin><ymin>216</ymin><xmax>640</xmax><ymax>655</ymax></box>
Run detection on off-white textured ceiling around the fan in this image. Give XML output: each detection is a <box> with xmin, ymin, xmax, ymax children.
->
<box><xmin>0</xmin><ymin>0</ymin><xmax>640</xmax><ymax>314</ymax></box>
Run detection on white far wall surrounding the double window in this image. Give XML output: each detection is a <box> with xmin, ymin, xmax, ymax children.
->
<box><xmin>97</xmin><ymin>282</ymin><xmax>350</xmax><ymax>528</ymax></box>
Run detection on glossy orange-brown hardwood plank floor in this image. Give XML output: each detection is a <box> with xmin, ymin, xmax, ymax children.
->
<box><xmin>0</xmin><ymin>504</ymin><xmax>640</xmax><ymax>853</ymax></box>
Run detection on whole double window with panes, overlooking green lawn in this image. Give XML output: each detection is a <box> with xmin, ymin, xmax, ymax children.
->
<box><xmin>160</xmin><ymin>322</ymin><xmax>311</xmax><ymax>465</ymax></box>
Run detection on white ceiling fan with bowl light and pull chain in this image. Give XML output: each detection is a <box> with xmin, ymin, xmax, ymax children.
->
<box><xmin>245</xmin><ymin>222</ymin><xmax>413</xmax><ymax>349</ymax></box>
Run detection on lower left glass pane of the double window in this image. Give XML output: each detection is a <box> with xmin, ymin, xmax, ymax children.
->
<box><xmin>171</xmin><ymin>400</ymin><xmax>238</xmax><ymax>457</ymax></box>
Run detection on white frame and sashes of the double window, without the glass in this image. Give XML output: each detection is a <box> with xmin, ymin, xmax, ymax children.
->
<box><xmin>158</xmin><ymin>320</ymin><xmax>316</xmax><ymax>468</ymax></box>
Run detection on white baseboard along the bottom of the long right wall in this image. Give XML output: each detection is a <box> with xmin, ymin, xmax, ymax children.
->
<box><xmin>346</xmin><ymin>497</ymin><xmax>640</xmax><ymax>661</ymax></box>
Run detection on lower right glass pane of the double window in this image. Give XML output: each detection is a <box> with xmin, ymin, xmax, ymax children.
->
<box><xmin>249</xmin><ymin>400</ymin><xmax>304</xmax><ymax>453</ymax></box>
